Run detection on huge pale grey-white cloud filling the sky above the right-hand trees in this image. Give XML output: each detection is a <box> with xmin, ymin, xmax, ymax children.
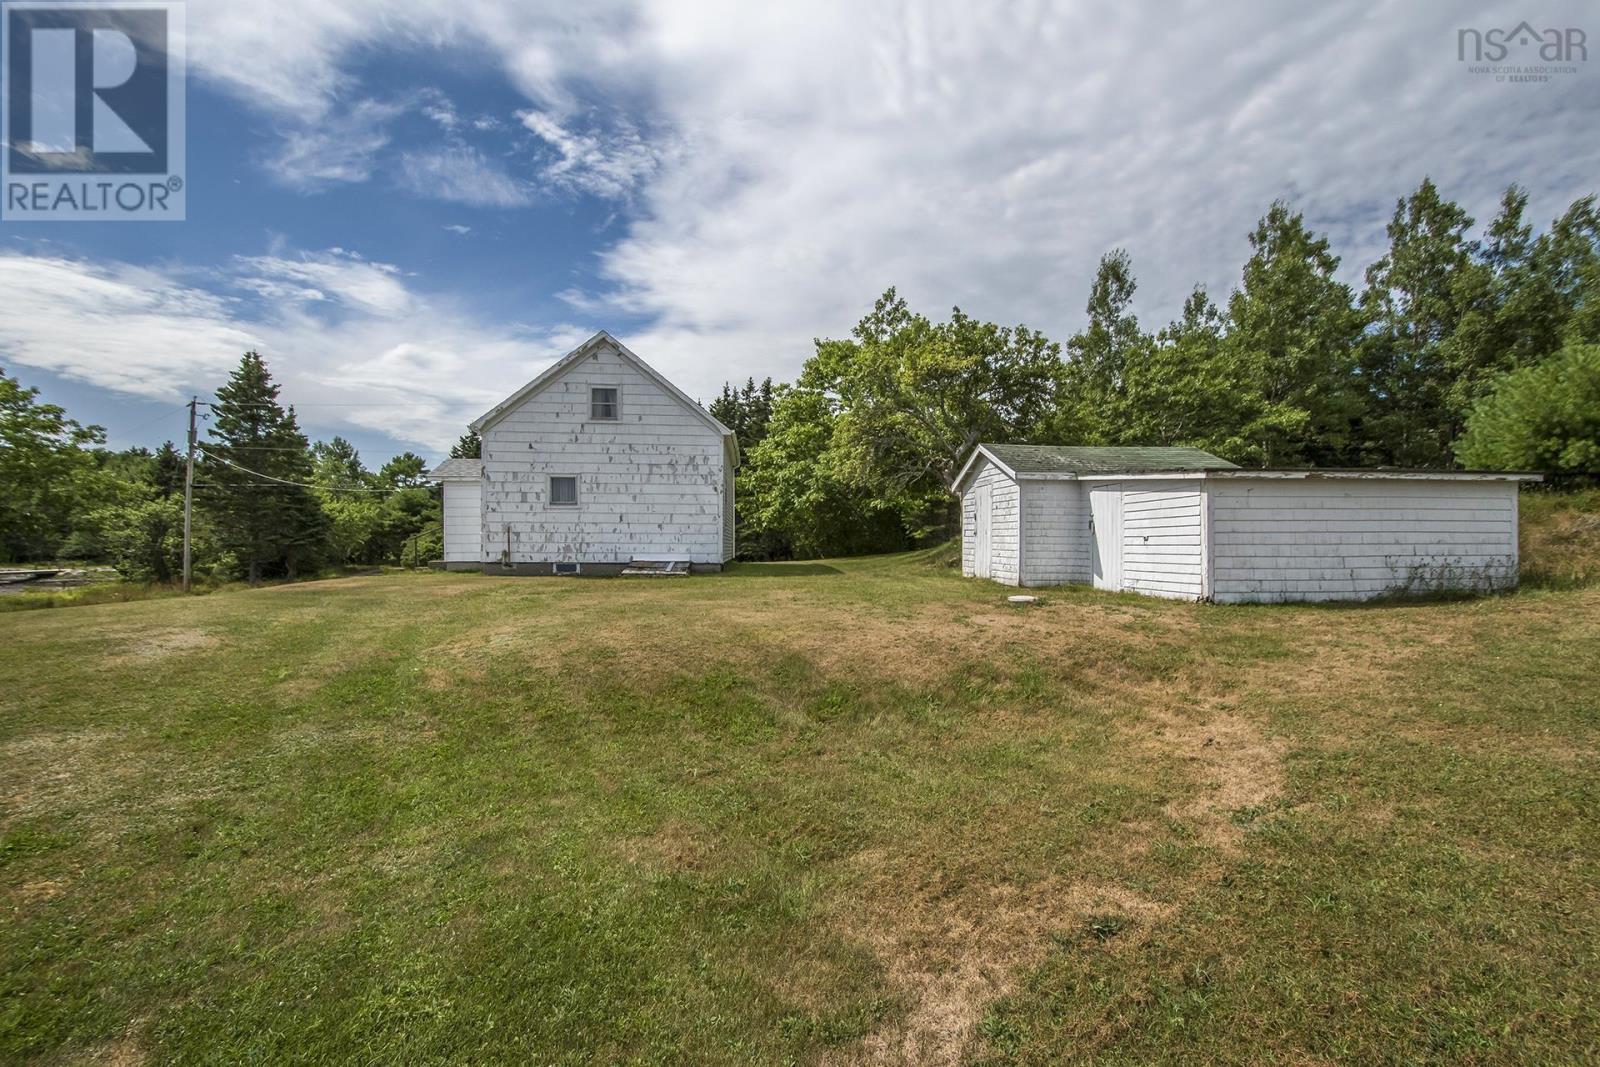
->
<box><xmin>165</xmin><ymin>0</ymin><xmax>1600</xmax><ymax>409</ymax></box>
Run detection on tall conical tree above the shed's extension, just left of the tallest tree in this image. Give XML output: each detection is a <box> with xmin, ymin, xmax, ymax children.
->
<box><xmin>1222</xmin><ymin>202</ymin><xmax>1362</xmax><ymax>467</ymax></box>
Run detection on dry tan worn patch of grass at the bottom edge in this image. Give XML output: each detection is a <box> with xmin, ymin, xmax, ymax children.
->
<box><xmin>827</xmin><ymin>853</ymin><xmax>1173</xmax><ymax>1064</ymax></box>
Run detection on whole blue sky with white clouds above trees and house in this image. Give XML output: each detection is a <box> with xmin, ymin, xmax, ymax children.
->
<box><xmin>0</xmin><ymin>0</ymin><xmax>1600</xmax><ymax>461</ymax></box>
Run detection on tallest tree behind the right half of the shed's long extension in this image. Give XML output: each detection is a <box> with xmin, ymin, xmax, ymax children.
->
<box><xmin>1360</xmin><ymin>178</ymin><xmax>1484</xmax><ymax>467</ymax></box>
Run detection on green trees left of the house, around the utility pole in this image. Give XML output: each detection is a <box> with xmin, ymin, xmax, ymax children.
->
<box><xmin>0</xmin><ymin>352</ymin><xmax>442</xmax><ymax>582</ymax></box>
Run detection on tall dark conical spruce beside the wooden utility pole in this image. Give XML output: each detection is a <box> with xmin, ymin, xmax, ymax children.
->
<box><xmin>203</xmin><ymin>352</ymin><xmax>328</xmax><ymax>584</ymax></box>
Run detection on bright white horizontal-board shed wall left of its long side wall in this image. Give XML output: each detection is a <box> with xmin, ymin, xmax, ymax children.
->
<box><xmin>1122</xmin><ymin>480</ymin><xmax>1205</xmax><ymax>600</ymax></box>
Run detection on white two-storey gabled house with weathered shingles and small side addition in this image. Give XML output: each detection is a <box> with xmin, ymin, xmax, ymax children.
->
<box><xmin>429</xmin><ymin>331</ymin><xmax>739</xmax><ymax>574</ymax></box>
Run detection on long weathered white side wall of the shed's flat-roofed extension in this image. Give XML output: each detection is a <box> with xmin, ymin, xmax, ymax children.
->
<box><xmin>1210</xmin><ymin>478</ymin><xmax>1517</xmax><ymax>603</ymax></box>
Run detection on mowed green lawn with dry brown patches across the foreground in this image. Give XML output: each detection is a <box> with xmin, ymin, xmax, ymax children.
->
<box><xmin>0</xmin><ymin>537</ymin><xmax>1600</xmax><ymax>1064</ymax></box>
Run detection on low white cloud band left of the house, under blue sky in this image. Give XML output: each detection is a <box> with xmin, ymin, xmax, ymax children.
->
<box><xmin>0</xmin><ymin>250</ymin><xmax>592</xmax><ymax>454</ymax></box>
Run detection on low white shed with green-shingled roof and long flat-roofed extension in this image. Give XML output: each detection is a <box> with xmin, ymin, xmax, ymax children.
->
<box><xmin>954</xmin><ymin>445</ymin><xmax>1539</xmax><ymax>603</ymax></box>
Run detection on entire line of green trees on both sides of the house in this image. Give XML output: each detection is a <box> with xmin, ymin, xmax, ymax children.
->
<box><xmin>0</xmin><ymin>181</ymin><xmax>1600</xmax><ymax>581</ymax></box>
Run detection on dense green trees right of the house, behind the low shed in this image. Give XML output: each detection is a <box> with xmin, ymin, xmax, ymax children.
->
<box><xmin>710</xmin><ymin>179</ymin><xmax>1600</xmax><ymax>558</ymax></box>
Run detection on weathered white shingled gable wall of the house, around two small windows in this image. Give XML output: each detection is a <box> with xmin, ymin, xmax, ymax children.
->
<box><xmin>482</xmin><ymin>344</ymin><xmax>731</xmax><ymax>563</ymax></box>
